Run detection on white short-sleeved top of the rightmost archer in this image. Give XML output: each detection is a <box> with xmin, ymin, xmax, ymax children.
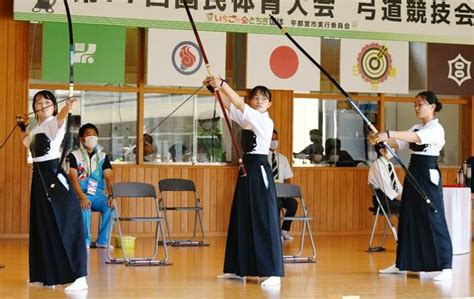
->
<box><xmin>397</xmin><ymin>118</ymin><xmax>446</xmax><ymax>156</ymax></box>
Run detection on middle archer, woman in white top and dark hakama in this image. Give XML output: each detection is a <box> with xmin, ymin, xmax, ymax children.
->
<box><xmin>204</xmin><ymin>77</ymin><xmax>284</xmax><ymax>286</ymax></box>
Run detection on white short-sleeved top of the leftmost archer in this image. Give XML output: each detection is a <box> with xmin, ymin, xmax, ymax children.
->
<box><xmin>23</xmin><ymin>116</ymin><xmax>66</xmax><ymax>162</ymax></box>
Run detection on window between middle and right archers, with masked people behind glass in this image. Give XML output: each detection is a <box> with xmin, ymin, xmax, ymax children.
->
<box><xmin>293</xmin><ymin>98</ymin><xmax>377</xmax><ymax>166</ymax></box>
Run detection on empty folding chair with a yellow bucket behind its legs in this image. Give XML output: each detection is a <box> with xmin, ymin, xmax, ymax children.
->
<box><xmin>107</xmin><ymin>182</ymin><xmax>171</xmax><ymax>266</ymax></box>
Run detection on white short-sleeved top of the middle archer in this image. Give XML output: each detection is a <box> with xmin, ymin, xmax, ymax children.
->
<box><xmin>229</xmin><ymin>104</ymin><xmax>273</xmax><ymax>155</ymax></box>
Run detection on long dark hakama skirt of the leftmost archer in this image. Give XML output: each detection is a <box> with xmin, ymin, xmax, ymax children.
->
<box><xmin>29</xmin><ymin>160</ymin><xmax>87</xmax><ymax>285</ymax></box>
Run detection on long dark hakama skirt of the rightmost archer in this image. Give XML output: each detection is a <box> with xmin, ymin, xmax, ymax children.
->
<box><xmin>396</xmin><ymin>155</ymin><xmax>453</xmax><ymax>271</ymax></box>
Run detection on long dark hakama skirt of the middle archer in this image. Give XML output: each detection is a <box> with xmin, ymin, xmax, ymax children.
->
<box><xmin>224</xmin><ymin>154</ymin><xmax>284</xmax><ymax>277</ymax></box>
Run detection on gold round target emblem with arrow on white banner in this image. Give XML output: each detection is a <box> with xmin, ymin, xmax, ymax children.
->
<box><xmin>353</xmin><ymin>43</ymin><xmax>397</xmax><ymax>90</ymax></box>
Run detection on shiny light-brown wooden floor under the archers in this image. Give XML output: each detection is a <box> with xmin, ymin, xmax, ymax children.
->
<box><xmin>0</xmin><ymin>236</ymin><xmax>474</xmax><ymax>298</ymax></box>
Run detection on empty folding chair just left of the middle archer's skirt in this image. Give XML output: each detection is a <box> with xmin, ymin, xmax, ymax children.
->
<box><xmin>158</xmin><ymin>179</ymin><xmax>209</xmax><ymax>246</ymax></box>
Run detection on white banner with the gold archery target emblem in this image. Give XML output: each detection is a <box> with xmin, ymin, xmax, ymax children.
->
<box><xmin>340</xmin><ymin>39</ymin><xmax>408</xmax><ymax>93</ymax></box>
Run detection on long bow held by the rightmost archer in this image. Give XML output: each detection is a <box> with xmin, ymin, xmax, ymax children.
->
<box><xmin>270</xmin><ymin>15</ymin><xmax>438</xmax><ymax>213</ymax></box>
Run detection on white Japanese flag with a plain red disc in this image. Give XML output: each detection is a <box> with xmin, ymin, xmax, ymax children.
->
<box><xmin>247</xmin><ymin>34</ymin><xmax>321</xmax><ymax>92</ymax></box>
